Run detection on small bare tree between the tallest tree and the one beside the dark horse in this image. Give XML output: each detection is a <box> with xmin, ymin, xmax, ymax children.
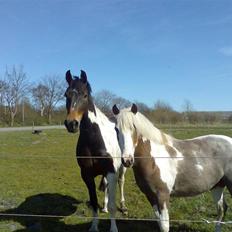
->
<box><xmin>31</xmin><ymin>83</ymin><xmax>49</xmax><ymax>117</ymax></box>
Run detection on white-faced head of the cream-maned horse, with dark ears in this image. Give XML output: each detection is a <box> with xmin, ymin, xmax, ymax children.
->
<box><xmin>112</xmin><ymin>104</ymin><xmax>138</xmax><ymax>167</ymax></box>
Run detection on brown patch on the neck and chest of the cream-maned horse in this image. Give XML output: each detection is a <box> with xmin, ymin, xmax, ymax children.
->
<box><xmin>133</xmin><ymin>138</ymin><xmax>170</xmax><ymax>210</ymax></box>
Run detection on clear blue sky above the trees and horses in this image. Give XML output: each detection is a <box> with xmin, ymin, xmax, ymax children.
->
<box><xmin>0</xmin><ymin>0</ymin><xmax>232</xmax><ymax>110</ymax></box>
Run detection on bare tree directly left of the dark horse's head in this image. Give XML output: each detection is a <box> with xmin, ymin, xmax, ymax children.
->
<box><xmin>42</xmin><ymin>75</ymin><xmax>65</xmax><ymax>123</ymax></box>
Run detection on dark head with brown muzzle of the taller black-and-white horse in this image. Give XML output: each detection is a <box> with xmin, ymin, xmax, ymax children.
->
<box><xmin>64</xmin><ymin>70</ymin><xmax>91</xmax><ymax>133</ymax></box>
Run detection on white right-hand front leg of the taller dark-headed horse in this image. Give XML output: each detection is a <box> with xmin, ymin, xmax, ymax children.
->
<box><xmin>106</xmin><ymin>173</ymin><xmax>118</xmax><ymax>232</ymax></box>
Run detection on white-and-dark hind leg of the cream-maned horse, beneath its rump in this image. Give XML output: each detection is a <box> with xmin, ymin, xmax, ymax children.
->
<box><xmin>211</xmin><ymin>186</ymin><xmax>227</xmax><ymax>232</ymax></box>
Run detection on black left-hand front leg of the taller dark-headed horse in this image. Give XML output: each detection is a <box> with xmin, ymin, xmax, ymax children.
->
<box><xmin>81</xmin><ymin>170</ymin><xmax>99</xmax><ymax>232</ymax></box>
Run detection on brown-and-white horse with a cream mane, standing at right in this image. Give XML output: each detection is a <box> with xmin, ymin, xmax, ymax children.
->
<box><xmin>113</xmin><ymin>104</ymin><xmax>232</xmax><ymax>232</ymax></box>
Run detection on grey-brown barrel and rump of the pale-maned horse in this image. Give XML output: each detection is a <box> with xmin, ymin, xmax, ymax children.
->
<box><xmin>173</xmin><ymin>135</ymin><xmax>232</xmax><ymax>196</ymax></box>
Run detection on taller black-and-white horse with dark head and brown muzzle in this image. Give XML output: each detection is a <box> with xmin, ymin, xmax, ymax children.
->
<box><xmin>64</xmin><ymin>70</ymin><xmax>126</xmax><ymax>232</ymax></box>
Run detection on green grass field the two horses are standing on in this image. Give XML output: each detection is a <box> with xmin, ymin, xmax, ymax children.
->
<box><xmin>0</xmin><ymin>127</ymin><xmax>232</xmax><ymax>232</ymax></box>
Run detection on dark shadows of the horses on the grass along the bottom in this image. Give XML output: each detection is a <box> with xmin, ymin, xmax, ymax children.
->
<box><xmin>0</xmin><ymin>193</ymin><xmax>203</xmax><ymax>232</ymax></box>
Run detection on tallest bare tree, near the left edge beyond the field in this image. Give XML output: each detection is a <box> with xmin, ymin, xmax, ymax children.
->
<box><xmin>3</xmin><ymin>66</ymin><xmax>29</xmax><ymax>126</ymax></box>
